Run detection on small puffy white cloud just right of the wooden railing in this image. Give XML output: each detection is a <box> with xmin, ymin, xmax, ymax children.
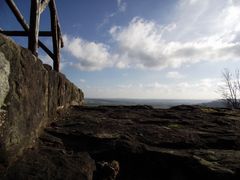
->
<box><xmin>63</xmin><ymin>35</ymin><xmax>113</xmax><ymax>71</ymax></box>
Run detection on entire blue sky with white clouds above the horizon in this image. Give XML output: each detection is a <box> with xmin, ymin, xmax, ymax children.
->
<box><xmin>0</xmin><ymin>0</ymin><xmax>240</xmax><ymax>99</ymax></box>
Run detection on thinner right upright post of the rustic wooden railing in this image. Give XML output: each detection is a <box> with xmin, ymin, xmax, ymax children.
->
<box><xmin>49</xmin><ymin>0</ymin><xmax>60</xmax><ymax>71</ymax></box>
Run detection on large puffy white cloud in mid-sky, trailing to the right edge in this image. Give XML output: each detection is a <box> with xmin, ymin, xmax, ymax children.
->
<box><xmin>109</xmin><ymin>14</ymin><xmax>240</xmax><ymax>69</ymax></box>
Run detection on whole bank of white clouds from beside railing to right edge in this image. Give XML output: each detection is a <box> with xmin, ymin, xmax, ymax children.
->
<box><xmin>64</xmin><ymin>0</ymin><xmax>240</xmax><ymax>71</ymax></box>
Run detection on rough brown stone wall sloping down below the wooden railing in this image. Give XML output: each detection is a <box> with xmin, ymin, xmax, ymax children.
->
<box><xmin>0</xmin><ymin>34</ymin><xmax>83</xmax><ymax>163</ymax></box>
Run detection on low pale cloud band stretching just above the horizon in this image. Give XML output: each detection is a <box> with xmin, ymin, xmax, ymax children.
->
<box><xmin>85</xmin><ymin>79</ymin><xmax>221</xmax><ymax>99</ymax></box>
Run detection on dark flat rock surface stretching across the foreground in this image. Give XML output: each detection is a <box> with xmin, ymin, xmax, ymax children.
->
<box><xmin>2</xmin><ymin>105</ymin><xmax>240</xmax><ymax>180</ymax></box>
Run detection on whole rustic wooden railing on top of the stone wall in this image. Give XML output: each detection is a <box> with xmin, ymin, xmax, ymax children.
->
<box><xmin>0</xmin><ymin>0</ymin><xmax>64</xmax><ymax>71</ymax></box>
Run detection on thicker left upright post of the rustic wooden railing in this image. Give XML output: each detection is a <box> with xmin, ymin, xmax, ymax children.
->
<box><xmin>28</xmin><ymin>0</ymin><xmax>40</xmax><ymax>56</ymax></box>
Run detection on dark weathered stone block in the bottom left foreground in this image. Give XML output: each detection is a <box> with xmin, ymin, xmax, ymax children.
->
<box><xmin>3</xmin><ymin>147</ymin><xmax>95</xmax><ymax>180</ymax></box>
